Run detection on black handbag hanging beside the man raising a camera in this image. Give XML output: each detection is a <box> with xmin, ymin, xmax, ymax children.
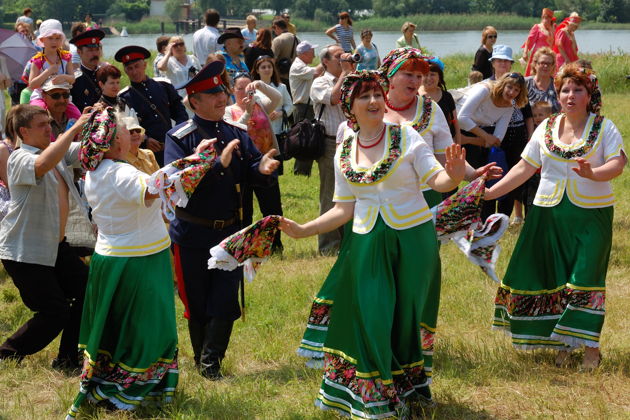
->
<box><xmin>282</xmin><ymin>98</ymin><xmax>326</xmax><ymax>160</ymax></box>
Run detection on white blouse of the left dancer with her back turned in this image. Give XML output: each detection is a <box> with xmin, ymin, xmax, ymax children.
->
<box><xmin>85</xmin><ymin>159</ymin><xmax>171</xmax><ymax>257</ymax></box>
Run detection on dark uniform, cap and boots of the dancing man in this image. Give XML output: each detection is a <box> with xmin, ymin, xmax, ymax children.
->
<box><xmin>165</xmin><ymin>62</ymin><xmax>277</xmax><ymax>379</ymax></box>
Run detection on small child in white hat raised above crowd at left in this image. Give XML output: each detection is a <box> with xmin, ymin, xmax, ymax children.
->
<box><xmin>28</xmin><ymin>19</ymin><xmax>81</xmax><ymax>115</ymax></box>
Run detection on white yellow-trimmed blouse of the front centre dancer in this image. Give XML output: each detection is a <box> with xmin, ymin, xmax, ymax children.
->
<box><xmin>333</xmin><ymin>123</ymin><xmax>444</xmax><ymax>234</ymax></box>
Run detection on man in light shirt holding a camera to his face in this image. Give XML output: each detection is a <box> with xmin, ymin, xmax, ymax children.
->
<box><xmin>310</xmin><ymin>45</ymin><xmax>354</xmax><ymax>255</ymax></box>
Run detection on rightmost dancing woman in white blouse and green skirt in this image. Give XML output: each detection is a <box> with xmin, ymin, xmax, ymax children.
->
<box><xmin>485</xmin><ymin>64</ymin><xmax>627</xmax><ymax>369</ymax></box>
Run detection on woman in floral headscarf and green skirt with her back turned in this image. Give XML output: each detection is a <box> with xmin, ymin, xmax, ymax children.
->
<box><xmin>67</xmin><ymin>108</ymin><xmax>216</xmax><ymax>419</ymax></box>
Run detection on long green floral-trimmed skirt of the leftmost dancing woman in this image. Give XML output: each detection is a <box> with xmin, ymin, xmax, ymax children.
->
<box><xmin>67</xmin><ymin>249</ymin><xmax>179</xmax><ymax>419</ymax></box>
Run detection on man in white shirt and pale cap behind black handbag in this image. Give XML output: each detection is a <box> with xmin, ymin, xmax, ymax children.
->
<box><xmin>289</xmin><ymin>41</ymin><xmax>324</xmax><ymax>176</ymax></box>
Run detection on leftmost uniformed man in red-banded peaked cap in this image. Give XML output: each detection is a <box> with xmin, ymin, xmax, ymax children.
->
<box><xmin>70</xmin><ymin>29</ymin><xmax>105</xmax><ymax>112</ymax></box>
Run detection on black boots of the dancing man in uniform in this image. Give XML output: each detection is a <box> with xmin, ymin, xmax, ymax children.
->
<box><xmin>188</xmin><ymin>318</ymin><xmax>234</xmax><ymax>380</ymax></box>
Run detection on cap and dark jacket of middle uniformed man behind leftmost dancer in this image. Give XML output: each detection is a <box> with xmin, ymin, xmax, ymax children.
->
<box><xmin>114</xmin><ymin>46</ymin><xmax>188</xmax><ymax>166</ymax></box>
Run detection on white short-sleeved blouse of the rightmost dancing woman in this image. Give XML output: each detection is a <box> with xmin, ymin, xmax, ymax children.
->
<box><xmin>521</xmin><ymin>114</ymin><xmax>625</xmax><ymax>208</ymax></box>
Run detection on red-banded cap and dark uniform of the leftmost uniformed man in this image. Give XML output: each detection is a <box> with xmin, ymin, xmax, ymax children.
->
<box><xmin>70</xmin><ymin>29</ymin><xmax>105</xmax><ymax>112</ymax></box>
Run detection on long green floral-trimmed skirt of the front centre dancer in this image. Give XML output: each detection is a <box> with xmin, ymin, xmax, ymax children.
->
<box><xmin>316</xmin><ymin>217</ymin><xmax>440</xmax><ymax>418</ymax></box>
